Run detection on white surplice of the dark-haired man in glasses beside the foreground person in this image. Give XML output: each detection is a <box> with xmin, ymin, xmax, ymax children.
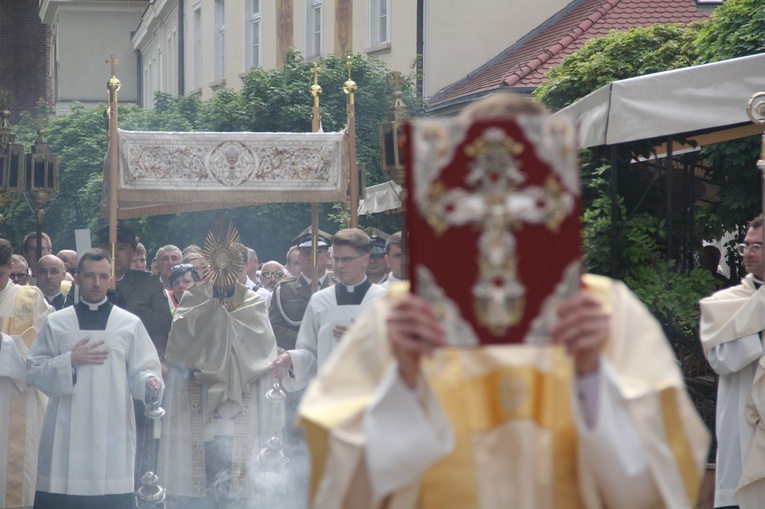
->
<box><xmin>283</xmin><ymin>283</ymin><xmax>386</xmax><ymax>391</ymax></box>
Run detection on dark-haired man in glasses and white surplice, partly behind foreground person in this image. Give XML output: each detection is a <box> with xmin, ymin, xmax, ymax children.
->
<box><xmin>271</xmin><ymin>228</ymin><xmax>386</xmax><ymax>391</ymax></box>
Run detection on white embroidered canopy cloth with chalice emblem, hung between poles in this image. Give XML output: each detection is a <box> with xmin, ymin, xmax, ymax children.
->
<box><xmin>101</xmin><ymin>130</ymin><xmax>349</xmax><ymax>219</ymax></box>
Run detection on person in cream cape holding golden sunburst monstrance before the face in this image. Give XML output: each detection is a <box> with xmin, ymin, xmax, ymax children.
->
<box><xmin>159</xmin><ymin>222</ymin><xmax>276</xmax><ymax>508</ymax></box>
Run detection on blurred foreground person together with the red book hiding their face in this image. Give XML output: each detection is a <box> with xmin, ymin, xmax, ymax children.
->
<box><xmin>300</xmin><ymin>95</ymin><xmax>709</xmax><ymax>509</ymax></box>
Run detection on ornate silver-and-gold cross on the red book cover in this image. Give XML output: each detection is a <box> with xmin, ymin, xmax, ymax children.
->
<box><xmin>425</xmin><ymin>127</ymin><xmax>574</xmax><ymax>336</ymax></box>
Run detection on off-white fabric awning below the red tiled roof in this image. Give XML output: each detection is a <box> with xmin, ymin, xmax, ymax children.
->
<box><xmin>557</xmin><ymin>53</ymin><xmax>765</xmax><ymax>147</ymax></box>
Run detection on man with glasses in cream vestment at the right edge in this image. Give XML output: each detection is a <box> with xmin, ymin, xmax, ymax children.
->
<box><xmin>699</xmin><ymin>216</ymin><xmax>765</xmax><ymax>508</ymax></box>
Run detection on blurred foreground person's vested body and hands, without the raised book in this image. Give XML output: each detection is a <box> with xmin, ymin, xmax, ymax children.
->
<box><xmin>300</xmin><ymin>276</ymin><xmax>709</xmax><ymax>509</ymax></box>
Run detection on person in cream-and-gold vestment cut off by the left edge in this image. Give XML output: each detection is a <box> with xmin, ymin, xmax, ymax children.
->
<box><xmin>0</xmin><ymin>239</ymin><xmax>49</xmax><ymax>507</ymax></box>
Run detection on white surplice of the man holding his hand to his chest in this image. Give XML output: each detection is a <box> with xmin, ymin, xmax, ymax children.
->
<box><xmin>28</xmin><ymin>306</ymin><xmax>161</xmax><ymax>495</ymax></box>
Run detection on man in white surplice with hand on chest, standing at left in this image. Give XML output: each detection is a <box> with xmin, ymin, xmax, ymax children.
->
<box><xmin>27</xmin><ymin>249</ymin><xmax>162</xmax><ymax>509</ymax></box>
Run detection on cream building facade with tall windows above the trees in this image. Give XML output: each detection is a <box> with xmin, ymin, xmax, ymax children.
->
<box><xmin>132</xmin><ymin>0</ymin><xmax>568</xmax><ymax>107</ymax></box>
